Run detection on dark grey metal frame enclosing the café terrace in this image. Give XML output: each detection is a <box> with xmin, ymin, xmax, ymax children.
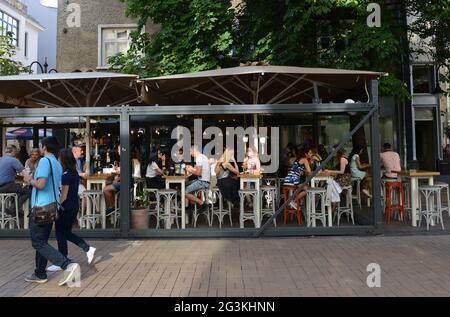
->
<box><xmin>0</xmin><ymin>68</ymin><xmax>382</xmax><ymax>238</ymax></box>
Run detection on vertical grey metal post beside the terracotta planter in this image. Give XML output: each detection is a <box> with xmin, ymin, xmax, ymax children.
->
<box><xmin>120</xmin><ymin>106</ymin><xmax>131</xmax><ymax>237</ymax></box>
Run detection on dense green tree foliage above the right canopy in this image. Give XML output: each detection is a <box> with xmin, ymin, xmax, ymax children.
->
<box><xmin>110</xmin><ymin>0</ymin><xmax>450</xmax><ymax>99</ymax></box>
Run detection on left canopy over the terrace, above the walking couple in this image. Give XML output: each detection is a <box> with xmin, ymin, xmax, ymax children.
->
<box><xmin>0</xmin><ymin>72</ymin><xmax>137</xmax><ymax>108</ymax></box>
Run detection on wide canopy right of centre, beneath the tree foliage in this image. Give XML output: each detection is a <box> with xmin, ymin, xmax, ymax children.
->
<box><xmin>139</xmin><ymin>66</ymin><xmax>385</xmax><ymax>105</ymax></box>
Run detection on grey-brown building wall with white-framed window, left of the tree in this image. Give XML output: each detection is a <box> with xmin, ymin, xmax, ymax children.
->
<box><xmin>57</xmin><ymin>0</ymin><xmax>157</xmax><ymax>72</ymax></box>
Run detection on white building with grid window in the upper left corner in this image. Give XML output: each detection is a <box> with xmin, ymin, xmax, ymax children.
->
<box><xmin>0</xmin><ymin>0</ymin><xmax>44</xmax><ymax>71</ymax></box>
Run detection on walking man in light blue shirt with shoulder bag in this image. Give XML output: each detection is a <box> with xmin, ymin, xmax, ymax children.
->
<box><xmin>24</xmin><ymin>137</ymin><xmax>80</xmax><ymax>286</ymax></box>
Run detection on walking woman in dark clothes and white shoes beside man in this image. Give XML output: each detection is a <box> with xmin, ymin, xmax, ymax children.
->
<box><xmin>47</xmin><ymin>149</ymin><xmax>96</xmax><ymax>272</ymax></box>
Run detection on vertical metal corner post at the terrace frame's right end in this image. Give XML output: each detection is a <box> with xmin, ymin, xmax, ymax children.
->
<box><xmin>370</xmin><ymin>80</ymin><xmax>383</xmax><ymax>226</ymax></box>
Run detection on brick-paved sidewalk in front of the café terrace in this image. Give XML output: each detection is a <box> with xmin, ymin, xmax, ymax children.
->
<box><xmin>0</xmin><ymin>236</ymin><xmax>450</xmax><ymax>297</ymax></box>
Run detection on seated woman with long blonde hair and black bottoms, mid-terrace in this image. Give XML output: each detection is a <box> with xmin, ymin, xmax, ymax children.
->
<box><xmin>214</xmin><ymin>148</ymin><xmax>239</xmax><ymax>206</ymax></box>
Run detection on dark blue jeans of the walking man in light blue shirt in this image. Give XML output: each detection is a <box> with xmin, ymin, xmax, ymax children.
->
<box><xmin>30</xmin><ymin>219</ymin><xmax>70</xmax><ymax>279</ymax></box>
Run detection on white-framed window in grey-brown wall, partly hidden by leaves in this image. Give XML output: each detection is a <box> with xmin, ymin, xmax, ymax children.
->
<box><xmin>99</xmin><ymin>26</ymin><xmax>136</xmax><ymax>67</ymax></box>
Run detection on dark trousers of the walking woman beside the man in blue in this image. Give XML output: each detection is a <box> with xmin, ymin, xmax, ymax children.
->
<box><xmin>55</xmin><ymin>210</ymin><xmax>90</xmax><ymax>257</ymax></box>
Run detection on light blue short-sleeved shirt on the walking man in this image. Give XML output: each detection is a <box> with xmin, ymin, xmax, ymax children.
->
<box><xmin>31</xmin><ymin>155</ymin><xmax>62</xmax><ymax>207</ymax></box>
